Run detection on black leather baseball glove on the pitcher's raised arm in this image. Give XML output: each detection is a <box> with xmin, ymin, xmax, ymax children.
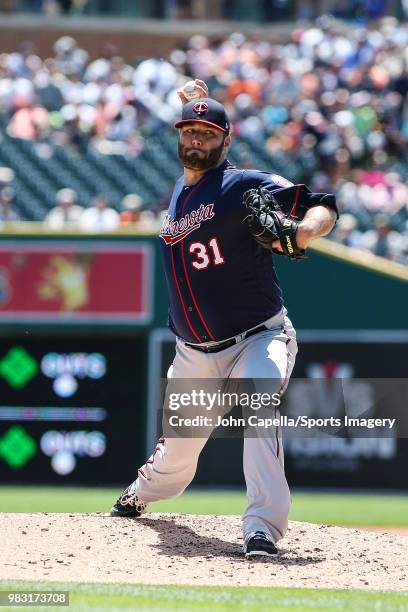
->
<box><xmin>244</xmin><ymin>187</ymin><xmax>305</xmax><ymax>259</ymax></box>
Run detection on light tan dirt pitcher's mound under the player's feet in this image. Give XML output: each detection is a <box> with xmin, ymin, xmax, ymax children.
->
<box><xmin>0</xmin><ymin>513</ymin><xmax>408</xmax><ymax>590</ymax></box>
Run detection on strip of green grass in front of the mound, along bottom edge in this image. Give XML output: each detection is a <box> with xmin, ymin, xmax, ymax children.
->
<box><xmin>0</xmin><ymin>582</ymin><xmax>408</xmax><ymax>612</ymax></box>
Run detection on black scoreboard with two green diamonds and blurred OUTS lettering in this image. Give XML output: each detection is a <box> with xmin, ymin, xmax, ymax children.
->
<box><xmin>0</xmin><ymin>336</ymin><xmax>147</xmax><ymax>485</ymax></box>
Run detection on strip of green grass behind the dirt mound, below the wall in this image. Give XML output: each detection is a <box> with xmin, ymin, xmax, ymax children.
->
<box><xmin>0</xmin><ymin>487</ymin><xmax>408</xmax><ymax>527</ymax></box>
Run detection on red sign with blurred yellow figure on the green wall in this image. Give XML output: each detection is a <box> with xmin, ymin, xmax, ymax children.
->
<box><xmin>0</xmin><ymin>239</ymin><xmax>154</xmax><ymax>325</ymax></box>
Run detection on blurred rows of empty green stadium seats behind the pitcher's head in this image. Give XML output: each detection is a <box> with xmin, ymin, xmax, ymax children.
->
<box><xmin>0</xmin><ymin>129</ymin><xmax>311</xmax><ymax>221</ymax></box>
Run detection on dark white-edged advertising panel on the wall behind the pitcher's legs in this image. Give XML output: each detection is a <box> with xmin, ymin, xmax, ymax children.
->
<box><xmin>147</xmin><ymin>330</ymin><xmax>408</xmax><ymax>490</ymax></box>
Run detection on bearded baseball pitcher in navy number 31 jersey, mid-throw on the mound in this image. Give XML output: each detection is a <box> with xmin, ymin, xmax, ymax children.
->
<box><xmin>111</xmin><ymin>81</ymin><xmax>338</xmax><ymax>558</ymax></box>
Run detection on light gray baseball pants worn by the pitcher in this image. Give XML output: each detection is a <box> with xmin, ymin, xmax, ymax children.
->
<box><xmin>128</xmin><ymin>308</ymin><xmax>297</xmax><ymax>542</ymax></box>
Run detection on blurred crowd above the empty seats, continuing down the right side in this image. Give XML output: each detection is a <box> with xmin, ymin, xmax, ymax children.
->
<box><xmin>0</xmin><ymin>17</ymin><xmax>408</xmax><ymax>263</ymax></box>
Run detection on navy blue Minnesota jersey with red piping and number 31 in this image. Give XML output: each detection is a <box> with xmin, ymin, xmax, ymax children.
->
<box><xmin>160</xmin><ymin>161</ymin><xmax>336</xmax><ymax>343</ymax></box>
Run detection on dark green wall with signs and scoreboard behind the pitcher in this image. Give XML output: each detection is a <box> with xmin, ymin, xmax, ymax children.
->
<box><xmin>0</xmin><ymin>234</ymin><xmax>408</xmax><ymax>488</ymax></box>
